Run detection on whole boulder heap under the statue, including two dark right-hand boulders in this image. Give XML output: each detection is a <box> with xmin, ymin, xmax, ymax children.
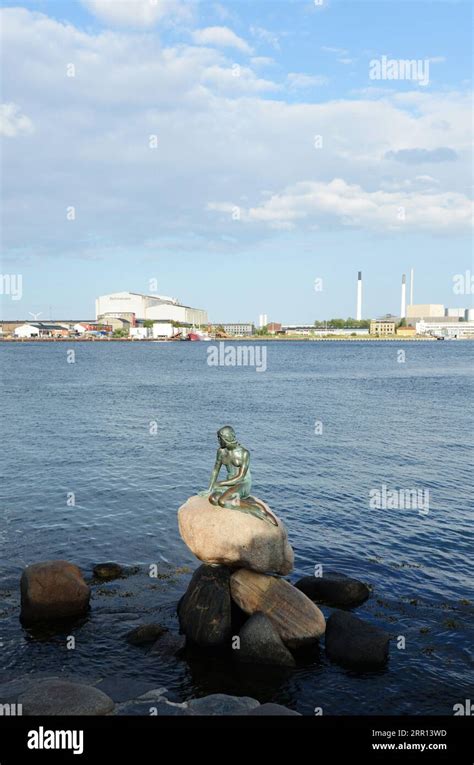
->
<box><xmin>178</xmin><ymin>496</ymin><xmax>389</xmax><ymax>669</ymax></box>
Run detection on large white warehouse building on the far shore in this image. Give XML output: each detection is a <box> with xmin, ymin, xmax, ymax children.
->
<box><xmin>95</xmin><ymin>292</ymin><xmax>208</xmax><ymax>325</ymax></box>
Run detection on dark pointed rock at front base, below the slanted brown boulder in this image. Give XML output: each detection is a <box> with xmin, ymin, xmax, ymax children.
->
<box><xmin>233</xmin><ymin>612</ymin><xmax>296</xmax><ymax>667</ymax></box>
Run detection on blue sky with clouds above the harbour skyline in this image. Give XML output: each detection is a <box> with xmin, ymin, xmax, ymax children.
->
<box><xmin>0</xmin><ymin>0</ymin><xmax>474</xmax><ymax>323</ymax></box>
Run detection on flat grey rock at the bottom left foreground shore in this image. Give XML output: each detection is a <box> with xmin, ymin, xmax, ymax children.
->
<box><xmin>18</xmin><ymin>680</ymin><xmax>115</xmax><ymax>716</ymax></box>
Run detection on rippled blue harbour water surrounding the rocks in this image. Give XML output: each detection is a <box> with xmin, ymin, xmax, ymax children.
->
<box><xmin>0</xmin><ymin>342</ymin><xmax>474</xmax><ymax>714</ymax></box>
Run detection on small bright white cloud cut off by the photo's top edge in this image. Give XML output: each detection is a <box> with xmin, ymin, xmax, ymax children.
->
<box><xmin>81</xmin><ymin>0</ymin><xmax>189</xmax><ymax>28</ymax></box>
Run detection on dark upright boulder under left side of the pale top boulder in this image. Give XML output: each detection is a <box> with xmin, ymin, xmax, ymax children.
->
<box><xmin>178</xmin><ymin>565</ymin><xmax>232</xmax><ymax>648</ymax></box>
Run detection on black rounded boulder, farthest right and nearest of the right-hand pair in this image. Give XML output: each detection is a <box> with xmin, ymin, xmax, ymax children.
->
<box><xmin>326</xmin><ymin>611</ymin><xmax>390</xmax><ymax>669</ymax></box>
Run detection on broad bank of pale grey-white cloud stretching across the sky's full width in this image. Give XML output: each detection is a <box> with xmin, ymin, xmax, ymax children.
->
<box><xmin>1</xmin><ymin>8</ymin><xmax>472</xmax><ymax>257</ymax></box>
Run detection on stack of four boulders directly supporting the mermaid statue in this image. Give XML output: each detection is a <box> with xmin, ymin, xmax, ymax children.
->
<box><xmin>178</xmin><ymin>497</ymin><xmax>326</xmax><ymax>667</ymax></box>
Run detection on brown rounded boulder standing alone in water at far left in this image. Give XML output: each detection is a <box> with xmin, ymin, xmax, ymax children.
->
<box><xmin>20</xmin><ymin>560</ymin><xmax>90</xmax><ymax>624</ymax></box>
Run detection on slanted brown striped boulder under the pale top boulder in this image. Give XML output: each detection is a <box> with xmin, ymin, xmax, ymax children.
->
<box><xmin>230</xmin><ymin>568</ymin><xmax>326</xmax><ymax>648</ymax></box>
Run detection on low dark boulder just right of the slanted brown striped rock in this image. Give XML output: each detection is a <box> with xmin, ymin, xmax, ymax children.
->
<box><xmin>295</xmin><ymin>571</ymin><xmax>370</xmax><ymax>608</ymax></box>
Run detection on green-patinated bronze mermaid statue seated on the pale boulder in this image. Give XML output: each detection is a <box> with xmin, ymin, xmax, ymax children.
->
<box><xmin>200</xmin><ymin>425</ymin><xmax>278</xmax><ymax>526</ymax></box>
